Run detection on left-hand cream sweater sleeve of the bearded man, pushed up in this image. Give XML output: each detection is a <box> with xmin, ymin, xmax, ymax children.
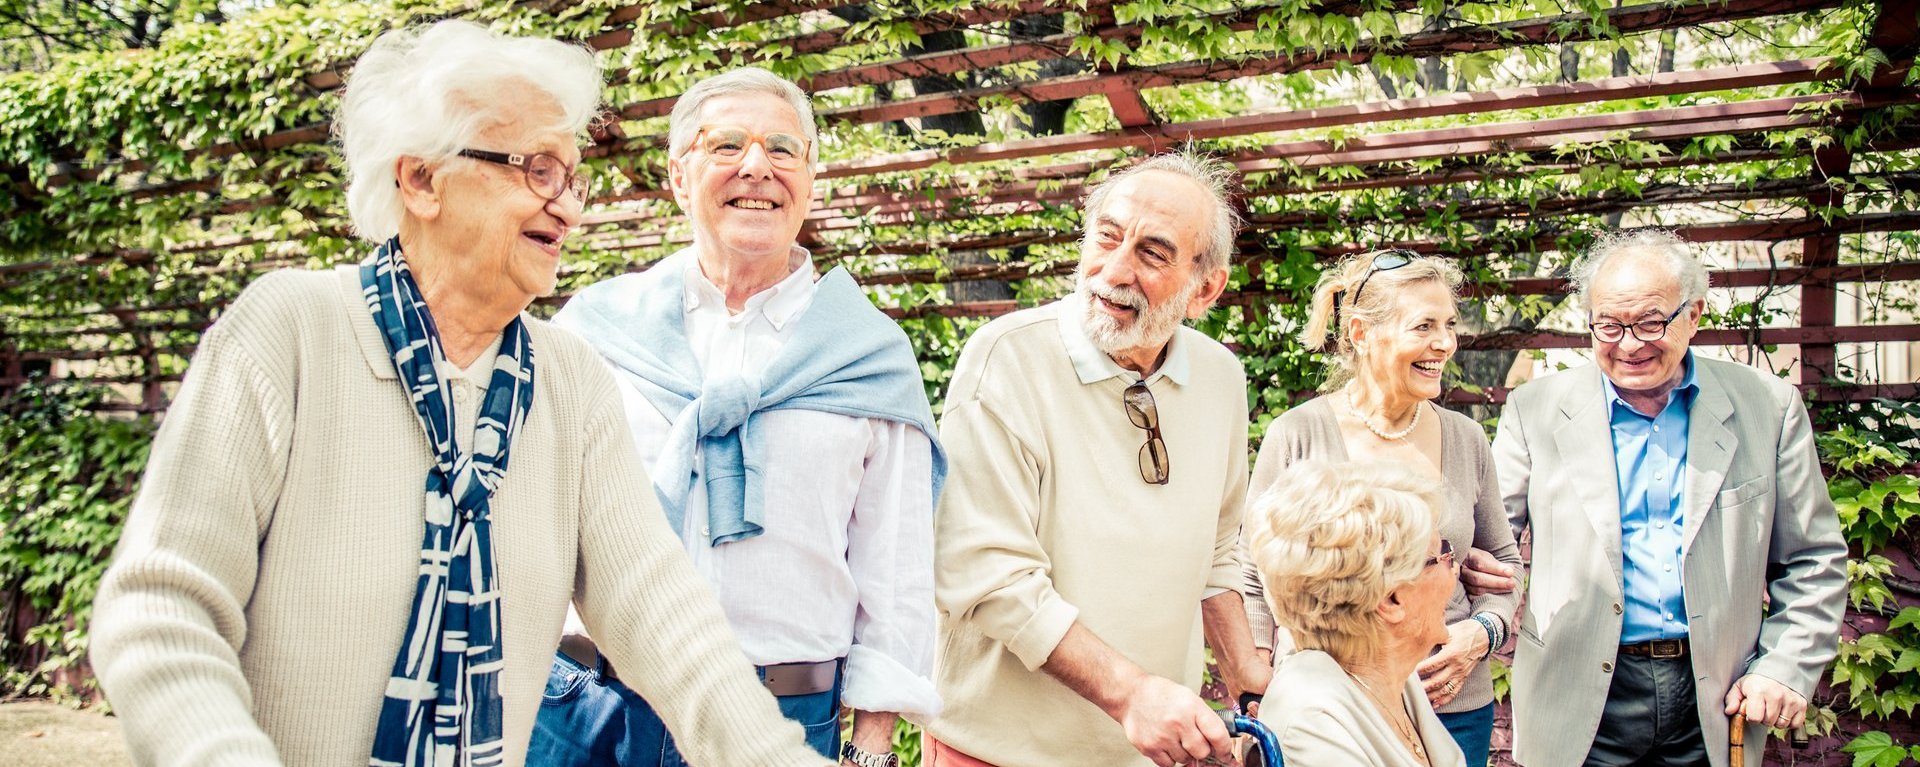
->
<box><xmin>933</xmin><ymin>395</ymin><xmax>1079</xmax><ymax>671</ymax></box>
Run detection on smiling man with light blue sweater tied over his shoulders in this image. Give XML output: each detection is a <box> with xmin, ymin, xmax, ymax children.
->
<box><xmin>528</xmin><ymin>69</ymin><xmax>945</xmax><ymax>767</ymax></box>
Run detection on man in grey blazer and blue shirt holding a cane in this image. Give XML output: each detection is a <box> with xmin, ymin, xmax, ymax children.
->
<box><xmin>1494</xmin><ymin>231</ymin><xmax>1847</xmax><ymax>767</ymax></box>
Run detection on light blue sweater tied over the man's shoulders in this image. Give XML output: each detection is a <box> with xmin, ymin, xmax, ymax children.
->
<box><xmin>553</xmin><ymin>248</ymin><xmax>947</xmax><ymax>546</ymax></box>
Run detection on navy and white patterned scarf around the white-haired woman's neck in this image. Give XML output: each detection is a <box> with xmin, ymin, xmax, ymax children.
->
<box><xmin>359</xmin><ymin>238</ymin><xmax>534</xmax><ymax>767</ymax></box>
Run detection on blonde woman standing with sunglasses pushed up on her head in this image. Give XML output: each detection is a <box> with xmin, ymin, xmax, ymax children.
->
<box><xmin>1246</xmin><ymin>250</ymin><xmax>1521</xmax><ymax>767</ymax></box>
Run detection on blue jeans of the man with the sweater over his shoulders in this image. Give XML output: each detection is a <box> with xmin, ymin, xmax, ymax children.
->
<box><xmin>526</xmin><ymin>654</ymin><xmax>845</xmax><ymax>767</ymax></box>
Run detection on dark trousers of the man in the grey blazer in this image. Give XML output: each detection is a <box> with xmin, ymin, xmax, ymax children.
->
<box><xmin>1586</xmin><ymin>654</ymin><xmax>1709</xmax><ymax>767</ymax></box>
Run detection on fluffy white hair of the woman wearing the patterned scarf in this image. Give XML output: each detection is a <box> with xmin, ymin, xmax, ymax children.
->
<box><xmin>334</xmin><ymin>19</ymin><xmax>603</xmax><ymax>242</ymax></box>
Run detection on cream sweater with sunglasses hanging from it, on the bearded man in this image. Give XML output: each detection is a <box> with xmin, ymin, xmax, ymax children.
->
<box><xmin>929</xmin><ymin>304</ymin><xmax>1246</xmax><ymax>767</ymax></box>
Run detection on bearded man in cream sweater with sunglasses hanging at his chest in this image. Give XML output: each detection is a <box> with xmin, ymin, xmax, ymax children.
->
<box><xmin>925</xmin><ymin>154</ymin><xmax>1269</xmax><ymax>767</ymax></box>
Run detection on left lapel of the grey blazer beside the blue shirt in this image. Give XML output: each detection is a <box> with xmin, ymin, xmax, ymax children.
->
<box><xmin>1553</xmin><ymin>365</ymin><xmax>1620</xmax><ymax>582</ymax></box>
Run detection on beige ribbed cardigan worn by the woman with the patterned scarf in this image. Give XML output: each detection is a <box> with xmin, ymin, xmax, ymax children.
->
<box><xmin>94</xmin><ymin>267</ymin><xmax>826</xmax><ymax>767</ymax></box>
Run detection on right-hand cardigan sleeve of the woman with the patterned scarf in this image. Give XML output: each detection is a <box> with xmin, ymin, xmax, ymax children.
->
<box><xmin>574</xmin><ymin>365</ymin><xmax>828</xmax><ymax>767</ymax></box>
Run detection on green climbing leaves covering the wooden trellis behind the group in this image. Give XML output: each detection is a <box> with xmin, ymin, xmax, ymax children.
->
<box><xmin>0</xmin><ymin>0</ymin><xmax>1920</xmax><ymax>759</ymax></box>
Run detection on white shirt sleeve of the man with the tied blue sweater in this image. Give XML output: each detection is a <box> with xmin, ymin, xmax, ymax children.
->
<box><xmin>841</xmin><ymin>419</ymin><xmax>941</xmax><ymax>719</ymax></box>
